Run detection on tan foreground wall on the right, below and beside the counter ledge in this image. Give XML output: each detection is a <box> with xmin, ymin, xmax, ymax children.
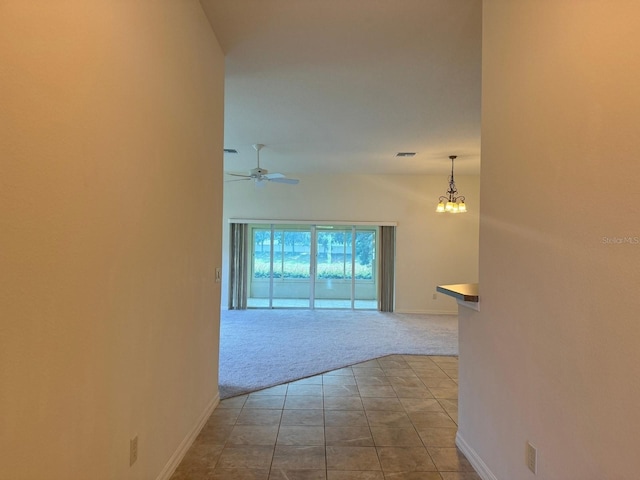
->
<box><xmin>459</xmin><ymin>0</ymin><xmax>640</xmax><ymax>480</ymax></box>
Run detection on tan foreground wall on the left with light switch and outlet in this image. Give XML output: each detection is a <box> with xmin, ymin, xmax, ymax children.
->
<box><xmin>0</xmin><ymin>0</ymin><xmax>224</xmax><ymax>480</ymax></box>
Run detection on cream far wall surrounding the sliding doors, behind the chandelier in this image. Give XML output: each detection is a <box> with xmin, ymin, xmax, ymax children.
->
<box><xmin>222</xmin><ymin>172</ymin><xmax>479</xmax><ymax>313</ymax></box>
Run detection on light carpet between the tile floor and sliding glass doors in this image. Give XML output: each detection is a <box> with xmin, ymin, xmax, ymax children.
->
<box><xmin>219</xmin><ymin>309</ymin><xmax>458</xmax><ymax>398</ymax></box>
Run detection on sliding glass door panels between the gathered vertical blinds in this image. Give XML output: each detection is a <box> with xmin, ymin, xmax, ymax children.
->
<box><xmin>247</xmin><ymin>224</ymin><xmax>378</xmax><ymax>309</ymax></box>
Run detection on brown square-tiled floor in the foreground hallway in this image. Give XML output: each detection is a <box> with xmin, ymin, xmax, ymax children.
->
<box><xmin>171</xmin><ymin>355</ymin><xmax>480</xmax><ymax>480</ymax></box>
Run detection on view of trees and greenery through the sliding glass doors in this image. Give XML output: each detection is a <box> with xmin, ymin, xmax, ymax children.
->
<box><xmin>252</xmin><ymin>227</ymin><xmax>376</xmax><ymax>281</ymax></box>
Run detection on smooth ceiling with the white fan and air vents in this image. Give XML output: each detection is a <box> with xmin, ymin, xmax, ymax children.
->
<box><xmin>201</xmin><ymin>0</ymin><xmax>482</xmax><ymax>175</ymax></box>
